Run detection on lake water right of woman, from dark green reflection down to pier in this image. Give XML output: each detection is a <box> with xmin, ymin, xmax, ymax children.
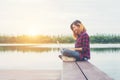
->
<box><xmin>90</xmin><ymin>48</ymin><xmax>120</xmax><ymax>80</ymax></box>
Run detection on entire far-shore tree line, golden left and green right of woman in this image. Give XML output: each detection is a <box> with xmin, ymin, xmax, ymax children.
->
<box><xmin>0</xmin><ymin>34</ymin><xmax>120</xmax><ymax>43</ymax></box>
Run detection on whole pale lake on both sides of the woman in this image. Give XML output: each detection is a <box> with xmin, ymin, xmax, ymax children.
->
<box><xmin>0</xmin><ymin>44</ymin><xmax>120</xmax><ymax>80</ymax></box>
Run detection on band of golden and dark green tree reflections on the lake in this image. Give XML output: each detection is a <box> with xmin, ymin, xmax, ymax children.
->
<box><xmin>0</xmin><ymin>46</ymin><xmax>120</xmax><ymax>53</ymax></box>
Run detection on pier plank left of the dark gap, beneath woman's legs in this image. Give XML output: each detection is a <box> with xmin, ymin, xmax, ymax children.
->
<box><xmin>61</xmin><ymin>62</ymin><xmax>86</xmax><ymax>80</ymax></box>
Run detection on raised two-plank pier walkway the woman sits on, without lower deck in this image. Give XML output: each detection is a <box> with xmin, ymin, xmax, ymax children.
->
<box><xmin>61</xmin><ymin>61</ymin><xmax>113</xmax><ymax>80</ymax></box>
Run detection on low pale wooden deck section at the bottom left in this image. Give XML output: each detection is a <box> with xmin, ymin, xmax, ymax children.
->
<box><xmin>0</xmin><ymin>70</ymin><xmax>61</xmax><ymax>80</ymax></box>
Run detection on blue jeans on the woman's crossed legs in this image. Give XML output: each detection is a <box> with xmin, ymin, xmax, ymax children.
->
<box><xmin>61</xmin><ymin>48</ymin><xmax>80</xmax><ymax>61</ymax></box>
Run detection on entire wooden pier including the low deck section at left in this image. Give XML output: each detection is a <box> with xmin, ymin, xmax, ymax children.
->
<box><xmin>0</xmin><ymin>61</ymin><xmax>113</xmax><ymax>80</ymax></box>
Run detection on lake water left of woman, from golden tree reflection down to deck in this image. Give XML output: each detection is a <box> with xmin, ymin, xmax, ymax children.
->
<box><xmin>0</xmin><ymin>46</ymin><xmax>62</xmax><ymax>70</ymax></box>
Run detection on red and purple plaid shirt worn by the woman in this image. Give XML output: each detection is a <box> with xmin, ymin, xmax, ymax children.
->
<box><xmin>75</xmin><ymin>32</ymin><xmax>90</xmax><ymax>60</ymax></box>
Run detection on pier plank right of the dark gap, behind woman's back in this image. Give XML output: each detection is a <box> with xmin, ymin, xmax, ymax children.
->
<box><xmin>77</xmin><ymin>61</ymin><xmax>113</xmax><ymax>80</ymax></box>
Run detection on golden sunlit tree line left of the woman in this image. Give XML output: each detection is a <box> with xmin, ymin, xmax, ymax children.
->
<box><xmin>0</xmin><ymin>35</ymin><xmax>74</xmax><ymax>43</ymax></box>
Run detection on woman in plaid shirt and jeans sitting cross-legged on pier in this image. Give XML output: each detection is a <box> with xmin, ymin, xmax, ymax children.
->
<box><xmin>59</xmin><ymin>20</ymin><xmax>90</xmax><ymax>61</ymax></box>
